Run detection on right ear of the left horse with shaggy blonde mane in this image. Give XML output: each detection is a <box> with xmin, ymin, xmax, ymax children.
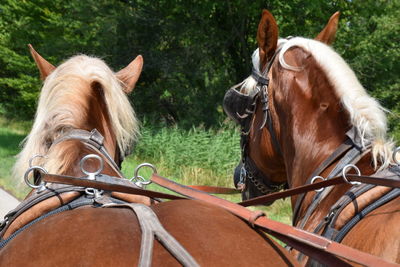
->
<box><xmin>116</xmin><ymin>55</ymin><xmax>143</xmax><ymax>94</ymax></box>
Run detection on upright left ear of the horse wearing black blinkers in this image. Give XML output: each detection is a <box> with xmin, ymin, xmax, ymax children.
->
<box><xmin>257</xmin><ymin>9</ymin><xmax>278</xmax><ymax>71</ymax></box>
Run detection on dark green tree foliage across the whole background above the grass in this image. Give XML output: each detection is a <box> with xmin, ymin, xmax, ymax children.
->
<box><xmin>0</xmin><ymin>0</ymin><xmax>400</xmax><ymax>128</ymax></box>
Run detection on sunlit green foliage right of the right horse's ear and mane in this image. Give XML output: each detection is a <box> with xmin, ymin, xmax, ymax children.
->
<box><xmin>335</xmin><ymin>0</ymin><xmax>400</xmax><ymax>132</ymax></box>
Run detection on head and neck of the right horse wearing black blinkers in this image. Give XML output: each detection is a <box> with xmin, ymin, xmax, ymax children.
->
<box><xmin>224</xmin><ymin>10</ymin><xmax>391</xmax><ymax>206</ymax></box>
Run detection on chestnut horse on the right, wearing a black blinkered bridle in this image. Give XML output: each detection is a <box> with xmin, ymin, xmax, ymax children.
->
<box><xmin>224</xmin><ymin>10</ymin><xmax>400</xmax><ymax>263</ymax></box>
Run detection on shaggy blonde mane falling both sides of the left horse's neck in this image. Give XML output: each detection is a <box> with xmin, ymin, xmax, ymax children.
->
<box><xmin>14</xmin><ymin>55</ymin><xmax>138</xmax><ymax>179</ymax></box>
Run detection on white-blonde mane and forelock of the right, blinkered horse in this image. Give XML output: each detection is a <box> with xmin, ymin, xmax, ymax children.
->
<box><xmin>241</xmin><ymin>37</ymin><xmax>394</xmax><ymax>168</ymax></box>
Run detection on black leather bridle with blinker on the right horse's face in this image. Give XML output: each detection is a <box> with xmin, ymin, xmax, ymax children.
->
<box><xmin>223</xmin><ymin>45</ymin><xmax>287</xmax><ymax>198</ymax></box>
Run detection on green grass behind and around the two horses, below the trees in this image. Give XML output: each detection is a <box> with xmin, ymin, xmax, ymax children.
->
<box><xmin>0</xmin><ymin>121</ymin><xmax>291</xmax><ymax>224</ymax></box>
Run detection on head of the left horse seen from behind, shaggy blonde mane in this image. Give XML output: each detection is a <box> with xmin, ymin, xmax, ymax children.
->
<box><xmin>14</xmin><ymin>45</ymin><xmax>143</xmax><ymax>186</ymax></box>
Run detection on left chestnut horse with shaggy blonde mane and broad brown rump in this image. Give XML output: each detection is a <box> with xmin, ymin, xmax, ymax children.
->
<box><xmin>0</xmin><ymin>49</ymin><xmax>297</xmax><ymax>266</ymax></box>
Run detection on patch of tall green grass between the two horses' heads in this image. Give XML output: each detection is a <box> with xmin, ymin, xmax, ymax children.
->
<box><xmin>133</xmin><ymin>125</ymin><xmax>240</xmax><ymax>186</ymax></box>
